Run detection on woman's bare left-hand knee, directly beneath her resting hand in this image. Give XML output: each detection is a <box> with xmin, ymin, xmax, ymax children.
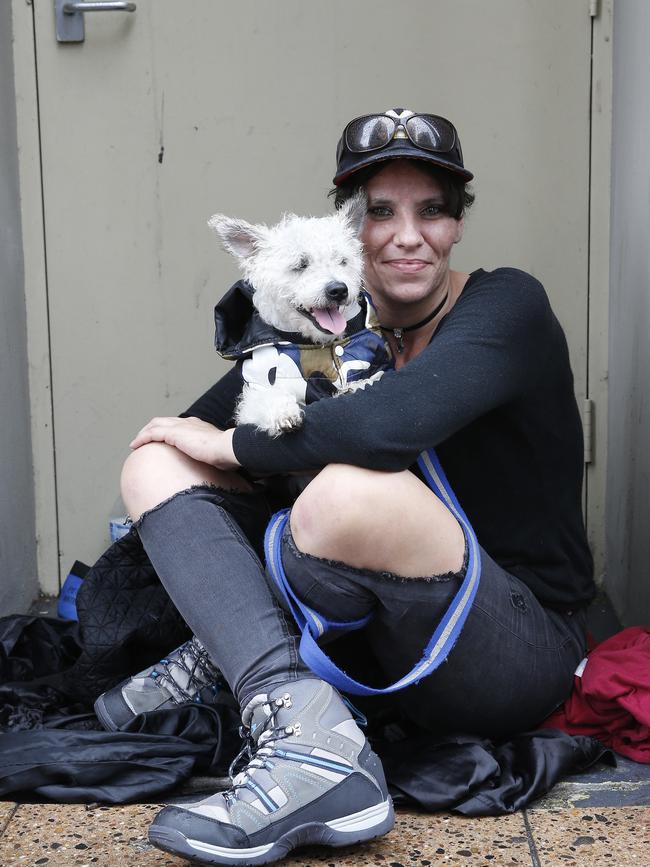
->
<box><xmin>120</xmin><ymin>443</ymin><xmax>250</xmax><ymax>520</ymax></box>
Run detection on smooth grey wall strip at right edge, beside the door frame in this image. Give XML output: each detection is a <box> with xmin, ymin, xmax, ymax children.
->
<box><xmin>603</xmin><ymin>0</ymin><xmax>650</xmax><ymax>625</ymax></box>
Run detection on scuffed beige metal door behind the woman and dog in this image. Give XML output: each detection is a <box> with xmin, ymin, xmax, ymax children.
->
<box><xmin>19</xmin><ymin>0</ymin><xmax>591</xmax><ymax>589</ymax></box>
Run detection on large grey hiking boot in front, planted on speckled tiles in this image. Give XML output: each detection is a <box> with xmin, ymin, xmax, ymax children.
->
<box><xmin>149</xmin><ymin>678</ymin><xmax>394</xmax><ymax>865</ymax></box>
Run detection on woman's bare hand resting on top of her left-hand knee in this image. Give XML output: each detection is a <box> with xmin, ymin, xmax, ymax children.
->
<box><xmin>129</xmin><ymin>417</ymin><xmax>241</xmax><ymax>470</ymax></box>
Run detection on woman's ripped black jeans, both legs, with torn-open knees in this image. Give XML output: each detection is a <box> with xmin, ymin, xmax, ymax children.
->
<box><xmin>138</xmin><ymin>486</ymin><xmax>585</xmax><ymax>737</ymax></box>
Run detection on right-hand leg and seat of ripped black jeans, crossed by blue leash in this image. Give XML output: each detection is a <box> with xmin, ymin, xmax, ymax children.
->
<box><xmin>282</xmin><ymin>526</ymin><xmax>586</xmax><ymax>737</ymax></box>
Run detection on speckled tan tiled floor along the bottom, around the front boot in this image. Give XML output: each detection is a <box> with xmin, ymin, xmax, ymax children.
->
<box><xmin>0</xmin><ymin>803</ymin><xmax>650</xmax><ymax>867</ymax></box>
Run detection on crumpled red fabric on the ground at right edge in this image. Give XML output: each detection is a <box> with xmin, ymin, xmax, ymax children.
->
<box><xmin>541</xmin><ymin>626</ymin><xmax>650</xmax><ymax>764</ymax></box>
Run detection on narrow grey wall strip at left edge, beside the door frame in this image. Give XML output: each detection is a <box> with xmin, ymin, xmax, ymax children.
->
<box><xmin>0</xmin><ymin>3</ymin><xmax>38</xmax><ymax>616</ymax></box>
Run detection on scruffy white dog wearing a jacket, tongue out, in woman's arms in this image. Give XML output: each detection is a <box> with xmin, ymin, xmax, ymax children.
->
<box><xmin>208</xmin><ymin>193</ymin><xmax>390</xmax><ymax>436</ymax></box>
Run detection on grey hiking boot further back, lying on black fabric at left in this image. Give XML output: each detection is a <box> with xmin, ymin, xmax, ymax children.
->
<box><xmin>95</xmin><ymin>637</ymin><xmax>228</xmax><ymax>731</ymax></box>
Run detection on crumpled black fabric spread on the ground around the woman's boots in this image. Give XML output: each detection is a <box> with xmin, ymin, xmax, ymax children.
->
<box><xmin>0</xmin><ymin>531</ymin><xmax>614</xmax><ymax>816</ymax></box>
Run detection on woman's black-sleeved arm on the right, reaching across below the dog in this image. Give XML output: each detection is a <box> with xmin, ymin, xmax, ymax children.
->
<box><xmin>232</xmin><ymin>269</ymin><xmax>563</xmax><ymax>473</ymax></box>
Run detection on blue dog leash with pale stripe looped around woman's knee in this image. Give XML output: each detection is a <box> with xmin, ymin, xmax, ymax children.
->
<box><xmin>264</xmin><ymin>449</ymin><xmax>481</xmax><ymax>695</ymax></box>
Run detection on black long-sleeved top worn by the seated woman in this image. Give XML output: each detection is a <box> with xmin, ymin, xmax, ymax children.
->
<box><xmin>187</xmin><ymin>268</ymin><xmax>595</xmax><ymax>610</ymax></box>
